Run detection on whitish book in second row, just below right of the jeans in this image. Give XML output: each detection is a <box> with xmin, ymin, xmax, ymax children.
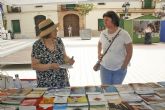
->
<box><xmin>120</xmin><ymin>94</ymin><xmax>143</xmax><ymax>102</ymax></box>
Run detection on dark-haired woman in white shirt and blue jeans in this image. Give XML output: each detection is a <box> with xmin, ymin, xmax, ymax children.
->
<box><xmin>98</xmin><ymin>11</ymin><xmax>133</xmax><ymax>85</ymax></box>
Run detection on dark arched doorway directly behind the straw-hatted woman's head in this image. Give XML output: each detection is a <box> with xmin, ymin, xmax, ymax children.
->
<box><xmin>34</xmin><ymin>15</ymin><xmax>46</xmax><ymax>36</ymax></box>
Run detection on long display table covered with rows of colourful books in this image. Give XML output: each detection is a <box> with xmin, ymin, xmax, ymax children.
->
<box><xmin>0</xmin><ymin>82</ymin><xmax>165</xmax><ymax>110</ymax></box>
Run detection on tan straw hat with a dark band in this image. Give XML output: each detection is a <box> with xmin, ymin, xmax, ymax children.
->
<box><xmin>38</xmin><ymin>18</ymin><xmax>58</xmax><ymax>38</ymax></box>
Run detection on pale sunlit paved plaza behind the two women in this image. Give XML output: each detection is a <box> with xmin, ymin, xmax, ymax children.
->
<box><xmin>0</xmin><ymin>37</ymin><xmax>165</xmax><ymax>86</ymax></box>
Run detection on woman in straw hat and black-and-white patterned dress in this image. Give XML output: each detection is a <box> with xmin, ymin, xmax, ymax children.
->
<box><xmin>31</xmin><ymin>19</ymin><xmax>74</xmax><ymax>88</ymax></box>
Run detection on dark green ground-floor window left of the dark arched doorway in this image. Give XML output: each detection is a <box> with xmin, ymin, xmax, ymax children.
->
<box><xmin>12</xmin><ymin>20</ymin><xmax>21</xmax><ymax>33</ymax></box>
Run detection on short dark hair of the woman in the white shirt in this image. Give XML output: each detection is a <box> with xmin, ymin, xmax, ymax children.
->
<box><xmin>103</xmin><ymin>11</ymin><xmax>120</xmax><ymax>26</ymax></box>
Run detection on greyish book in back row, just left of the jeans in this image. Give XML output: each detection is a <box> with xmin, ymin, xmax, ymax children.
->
<box><xmin>85</xmin><ymin>86</ymin><xmax>103</xmax><ymax>94</ymax></box>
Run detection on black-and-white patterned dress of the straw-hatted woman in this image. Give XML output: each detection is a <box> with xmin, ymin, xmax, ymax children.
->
<box><xmin>31</xmin><ymin>37</ymin><xmax>69</xmax><ymax>88</ymax></box>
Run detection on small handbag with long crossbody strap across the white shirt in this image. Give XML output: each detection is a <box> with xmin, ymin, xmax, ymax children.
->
<box><xmin>93</xmin><ymin>29</ymin><xmax>121</xmax><ymax>71</ymax></box>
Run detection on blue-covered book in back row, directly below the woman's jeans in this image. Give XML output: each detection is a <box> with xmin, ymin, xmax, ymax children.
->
<box><xmin>102</xmin><ymin>85</ymin><xmax>118</xmax><ymax>94</ymax></box>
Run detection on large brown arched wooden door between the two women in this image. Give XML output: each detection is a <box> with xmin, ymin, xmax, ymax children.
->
<box><xmin>63</xmin><ymin>14</ymin><xmax>79</xmax><ymax>37</ymax></box>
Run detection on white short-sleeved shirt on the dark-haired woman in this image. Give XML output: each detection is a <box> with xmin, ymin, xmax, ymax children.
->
<box><xmin>99</xmin><ymin>28</ymin><xmax>132</xmax><ymax>71</ymax></box>
